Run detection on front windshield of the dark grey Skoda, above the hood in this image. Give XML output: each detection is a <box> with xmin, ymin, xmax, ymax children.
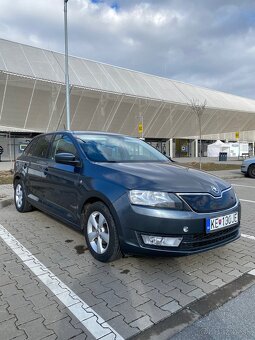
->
<box><xmin>75</xmin><ymin>134</ymin><xmax>169</xmax><ymax>163</ymax></box>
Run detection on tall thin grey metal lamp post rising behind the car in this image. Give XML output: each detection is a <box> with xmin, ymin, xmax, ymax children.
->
<box><xmin>64</xmin><ymin>0</ymin><xmax>70</xmax><ymax>130</ymax></box>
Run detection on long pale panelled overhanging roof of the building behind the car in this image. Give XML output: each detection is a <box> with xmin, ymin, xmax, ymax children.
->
<box><xmin>0</xmin><ymin>39</ymin><xmax>255</xmax><ymax>138</ymax></box>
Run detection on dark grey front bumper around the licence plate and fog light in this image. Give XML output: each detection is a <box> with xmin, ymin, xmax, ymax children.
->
<box><xmin>115</xmin><ymin>195</ymin><xmax>241</xmax><ymax>255</ymax></box>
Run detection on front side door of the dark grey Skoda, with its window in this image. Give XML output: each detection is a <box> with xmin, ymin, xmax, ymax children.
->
<box><xmin>45</xmin><ymin>133</ymin><xmax>81</xmax><ymax>224</ymax></box>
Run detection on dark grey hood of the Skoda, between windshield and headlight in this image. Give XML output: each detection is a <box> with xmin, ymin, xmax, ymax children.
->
<box><xmin>97</xmin><ymin>163</ymin><xmax>230</xmax><ymax>196</ymax></box>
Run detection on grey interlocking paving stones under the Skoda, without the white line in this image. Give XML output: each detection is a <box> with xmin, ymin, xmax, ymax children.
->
<box><xmin>0</xmin><ymin>199</ymin><xmax>255</xmax><ymax>340</ymax></box>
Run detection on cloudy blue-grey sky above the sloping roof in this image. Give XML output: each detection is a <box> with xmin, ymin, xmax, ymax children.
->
<box><xmin>0</xmin><ymin>0</ymin><xmax>255</xmax><ymax>98</ymax></box>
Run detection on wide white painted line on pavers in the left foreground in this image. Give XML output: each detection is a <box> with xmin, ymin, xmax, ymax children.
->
<box><xmin>0</xmin><ymin>224</ymin><xmax>124</xmax><ymax>340</ymax></box>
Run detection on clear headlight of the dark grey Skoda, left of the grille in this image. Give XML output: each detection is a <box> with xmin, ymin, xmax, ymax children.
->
<box><xmin>129</xmin><ymin>190</ymin><xmax>183</xmax><ymax>210</ymax></box>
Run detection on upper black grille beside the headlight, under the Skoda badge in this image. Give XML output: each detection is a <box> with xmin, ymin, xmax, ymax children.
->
<box><xmin>180</xmin><ymin>188</ymin><xmax>236</xmax><ymax>213</ymax></box>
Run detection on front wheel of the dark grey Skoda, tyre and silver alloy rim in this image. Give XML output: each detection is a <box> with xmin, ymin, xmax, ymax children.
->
<box><xmin>84</xmin><ymin>202</ymin><xmax>122</xmax><ymax>262</ymax></box>
